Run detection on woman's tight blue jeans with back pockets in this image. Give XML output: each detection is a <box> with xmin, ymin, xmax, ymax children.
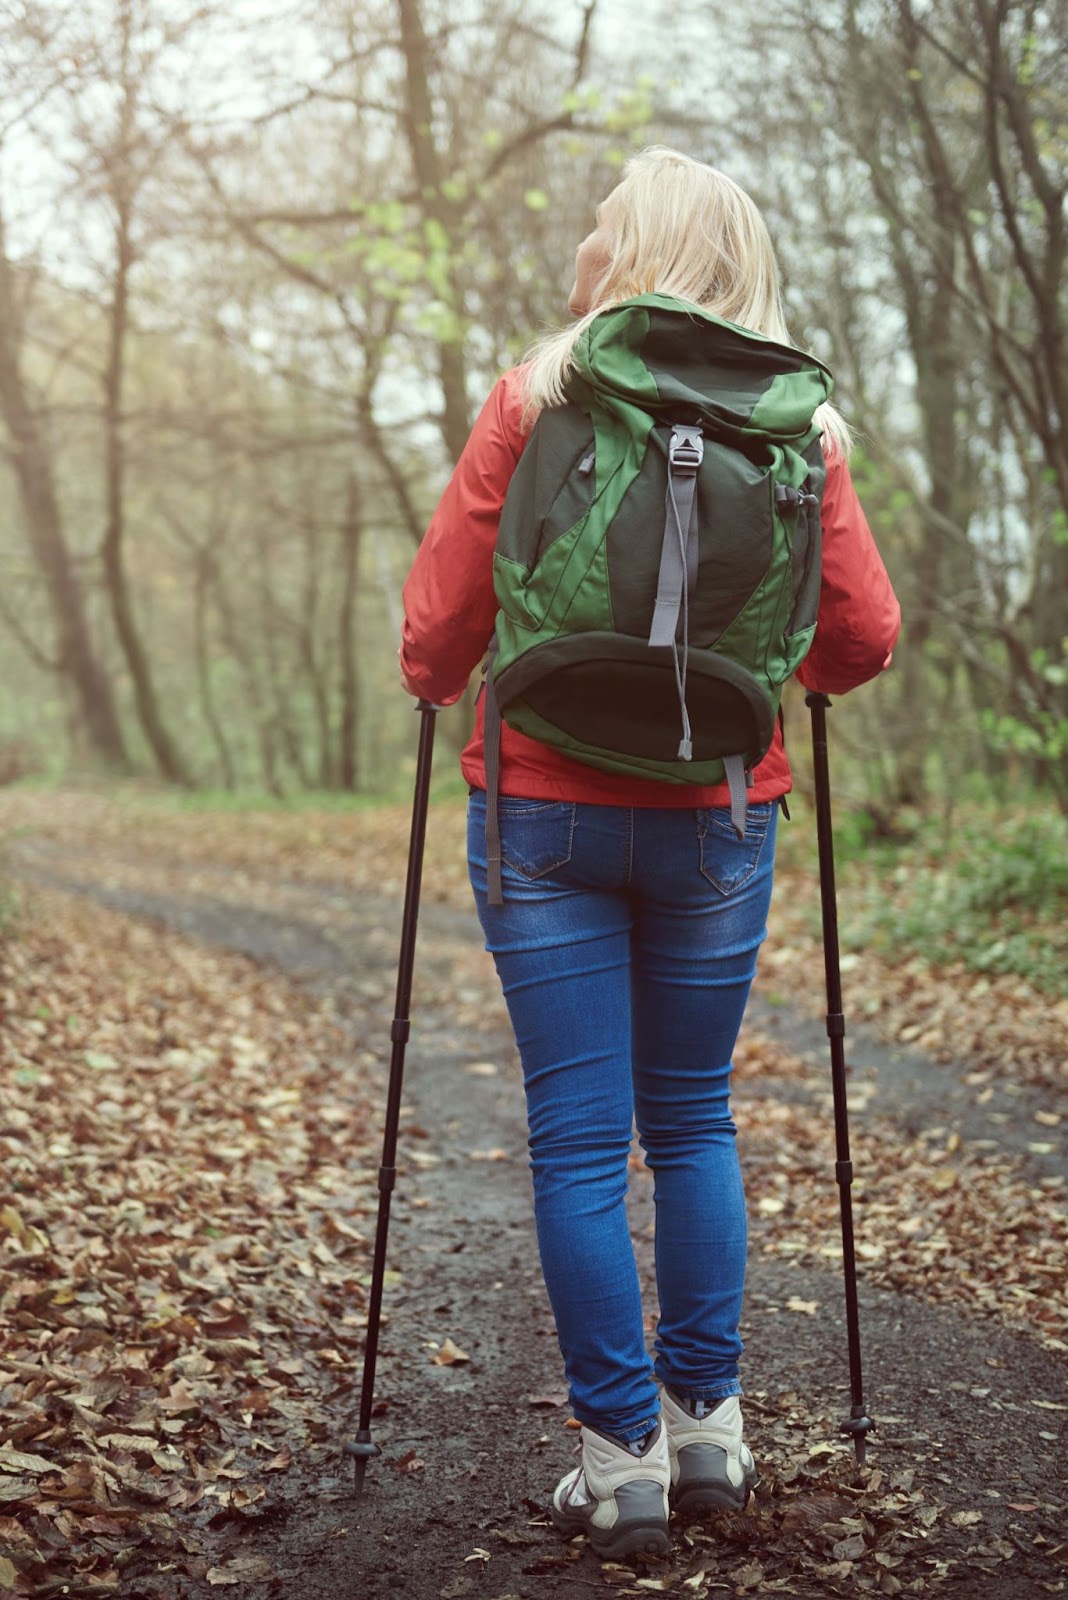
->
<box><xmin>468</xmin><ymin>790</ymin><xmax>779</xmax><ymax>1438</ymax></box>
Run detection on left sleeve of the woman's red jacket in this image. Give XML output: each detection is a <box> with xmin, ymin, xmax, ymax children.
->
<box><xmin>400</xmin><ymin>368</ymin><xmax>528</xmax><ymax>706</ymax></box>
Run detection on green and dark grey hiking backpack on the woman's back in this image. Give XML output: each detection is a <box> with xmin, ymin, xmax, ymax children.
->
<box><xmin>486</xmin><ymin>294</ymin><xmax>833</xmax><ymax>904</ymax></box>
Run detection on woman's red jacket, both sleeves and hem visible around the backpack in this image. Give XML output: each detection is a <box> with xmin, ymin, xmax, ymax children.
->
<box><xmin>400</xmin><ymin>368</ymin><xmax>900</xmax><ymax>806</ymax></box>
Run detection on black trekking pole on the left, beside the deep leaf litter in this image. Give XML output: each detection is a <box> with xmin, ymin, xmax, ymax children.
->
<box><xmin>344</xmin><ymin>699</ymin><xmax>441</xmax><ymax>1494</ymax></box>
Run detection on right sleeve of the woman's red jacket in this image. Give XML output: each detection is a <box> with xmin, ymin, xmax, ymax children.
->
<box><xmin>798</xmin><ymin>451</ymin><xmax>902</xmax><ymax>694</ymax></box>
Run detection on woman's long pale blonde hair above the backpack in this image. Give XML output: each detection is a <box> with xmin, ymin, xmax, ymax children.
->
<box><xmin>523</xmin><ymin>146</ymin><xmax>851</xmax><ymax>454</ymax></box>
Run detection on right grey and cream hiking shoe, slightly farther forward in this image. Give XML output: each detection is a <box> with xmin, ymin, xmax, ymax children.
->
<box><xmin>660</xmin><ymin>1389</ymin><xmax>756</xmax><ymax>1517</ymax></box>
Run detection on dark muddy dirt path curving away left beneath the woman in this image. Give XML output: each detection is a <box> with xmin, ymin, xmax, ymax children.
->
<box><xmin>10</xmin><ymin>842</ymin><xmax>1068</xmax><ymax>1600</ymax></box>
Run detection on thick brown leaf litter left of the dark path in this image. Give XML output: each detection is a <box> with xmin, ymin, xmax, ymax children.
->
<box><xmin>0</xmin><ymin>893</ymin><xmax>373</xmax><ymax>1595</ymax></box>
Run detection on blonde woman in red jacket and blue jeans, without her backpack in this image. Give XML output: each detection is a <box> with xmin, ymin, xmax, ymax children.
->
<box><xmin>401</xmin><ymin>149</ymin><xmax>900</xmax><ymax>1557</ymax></box>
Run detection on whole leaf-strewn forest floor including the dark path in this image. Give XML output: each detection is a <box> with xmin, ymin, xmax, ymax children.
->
<box><xmin>0</xmin><ymin>792</ymin><xmax>1068</xmax><ymax>1600</ymax></box>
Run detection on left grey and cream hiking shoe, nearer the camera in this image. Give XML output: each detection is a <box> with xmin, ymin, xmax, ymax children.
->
<box><xmin>550</xmin><ymin>1422</ymin><xmax>671</xmax><ymax>1560</ymax></box>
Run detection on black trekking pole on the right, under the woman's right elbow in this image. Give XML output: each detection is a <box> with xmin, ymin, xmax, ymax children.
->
<box><xmin>804</xmin><ymin>691</ymin><xmax>875</xmax><ymax>1466</ymax></box>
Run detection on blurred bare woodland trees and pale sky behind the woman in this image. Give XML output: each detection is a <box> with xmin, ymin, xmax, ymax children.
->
<box><xmin>0</xmin><ymin>0</ymin><xmax>1068</xmax><ymax>812</ymax></box>
